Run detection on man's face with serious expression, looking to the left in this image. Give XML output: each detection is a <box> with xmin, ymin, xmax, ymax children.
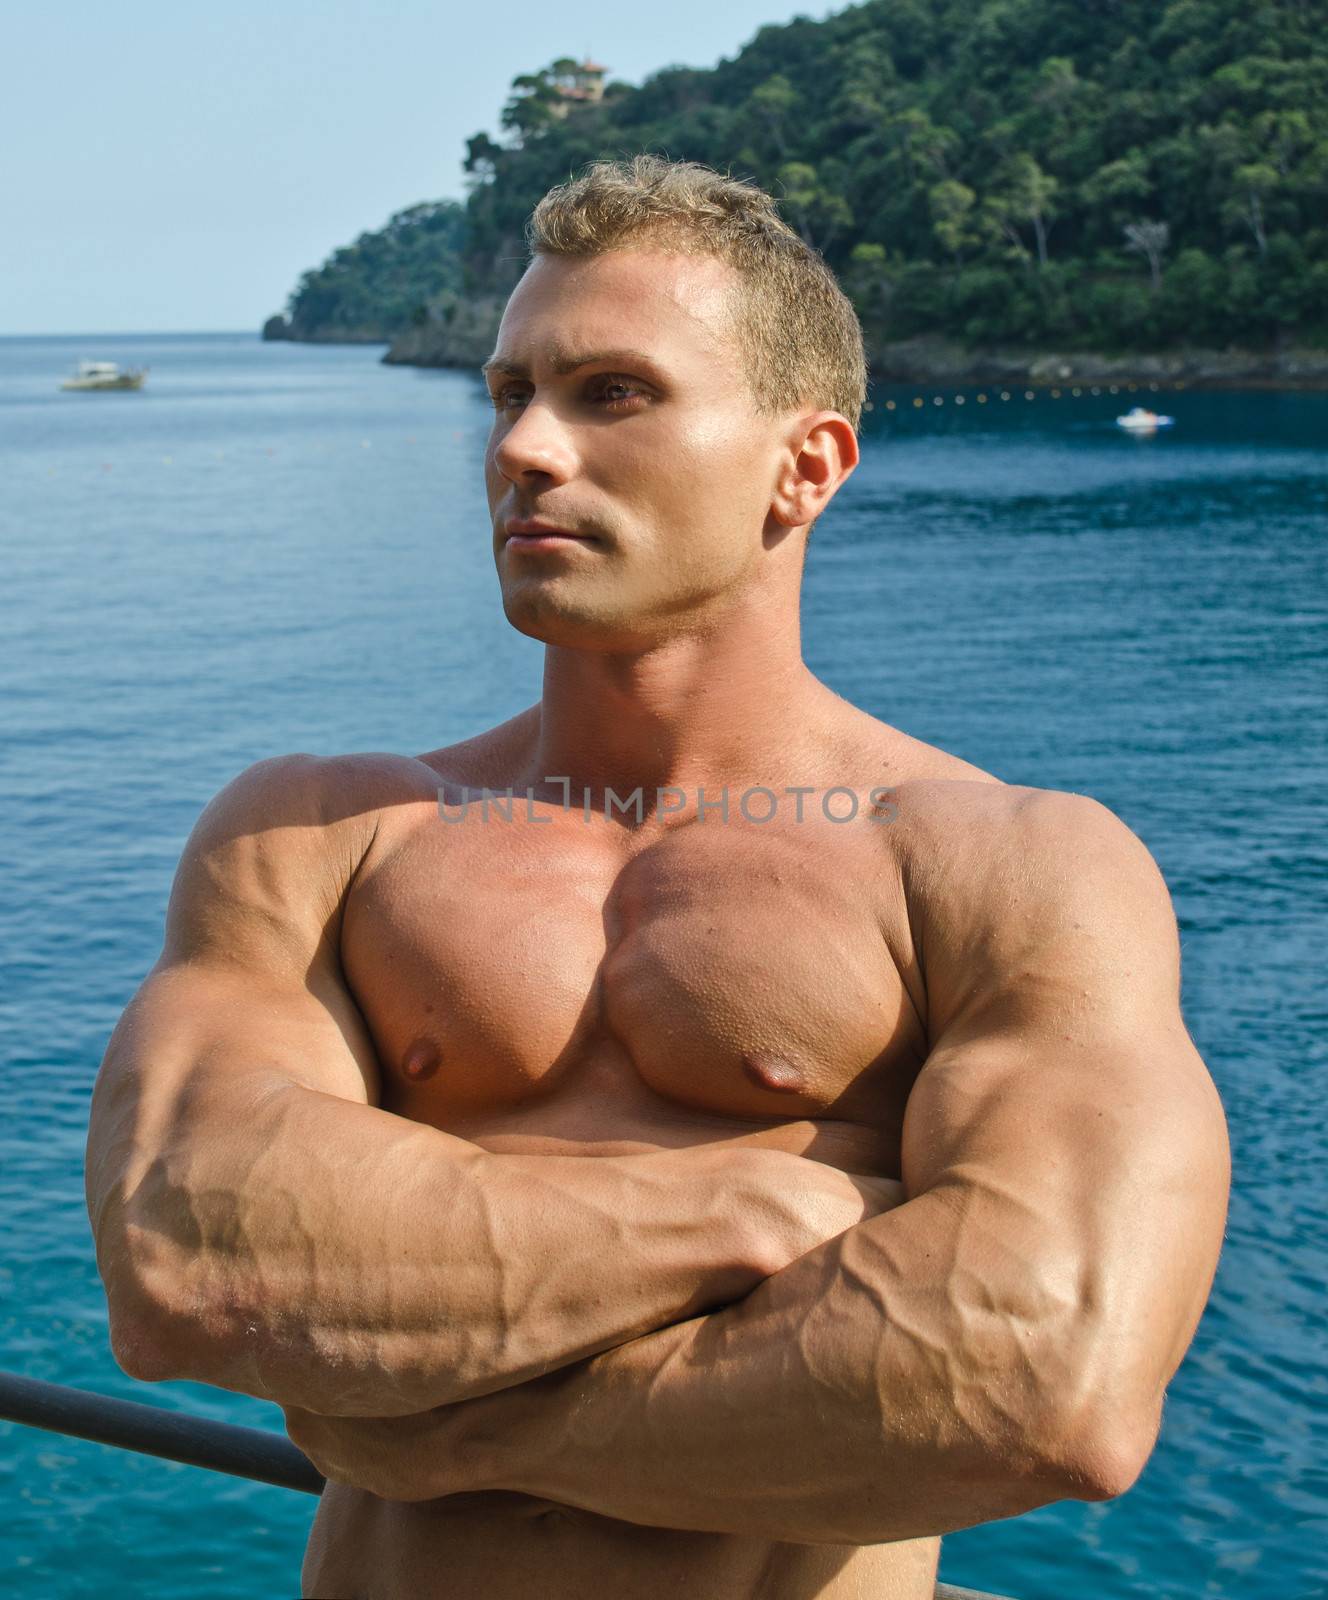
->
<box><xmin>485</xmin><ymin>251</ymin><xmax>789</xmax><ymax>650</ymax></box>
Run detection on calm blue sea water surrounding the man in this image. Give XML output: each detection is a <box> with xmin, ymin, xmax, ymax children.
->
<box><xmin>0</xmin><ymin>336</ymin><xmax>1328</xmax><ymax>1600</ymax></box>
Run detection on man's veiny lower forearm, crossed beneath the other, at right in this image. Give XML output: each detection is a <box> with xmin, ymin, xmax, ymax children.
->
<box><xmin>464</xmin><ymin>1197</ymin><xmax>1139</xmax><ymax>1544</ymax></box>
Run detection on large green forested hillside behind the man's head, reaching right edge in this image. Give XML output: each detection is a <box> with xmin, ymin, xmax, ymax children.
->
<box><xmin>273</xmin><ymin>0</ymin><xmax>1328</xmax><ymax>350</ymax></box>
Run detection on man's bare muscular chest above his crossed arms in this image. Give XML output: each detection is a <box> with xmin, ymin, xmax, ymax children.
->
<box><xmin>342</xmin><ymin>802</ymin><xmax>925</xmax><ymax>1173</ymax></box>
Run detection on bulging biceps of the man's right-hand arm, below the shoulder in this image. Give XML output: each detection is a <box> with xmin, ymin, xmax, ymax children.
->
<box><xmin>904</xmin><ymin>1024</ymin><xmax>1229</xmax><ymax>1395</ymax></box>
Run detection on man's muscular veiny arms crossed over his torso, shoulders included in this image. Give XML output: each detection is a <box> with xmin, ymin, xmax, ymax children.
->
<box><xmin>88</xmin><ymin>757</ymin><xmax>1229</xmax><ymax>1542</ymax></box>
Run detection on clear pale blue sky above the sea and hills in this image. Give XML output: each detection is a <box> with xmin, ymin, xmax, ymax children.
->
<box><xmin>0</xmin><ymin>0</ymin><xmax>840</xmax><ymax>333</ymax></box>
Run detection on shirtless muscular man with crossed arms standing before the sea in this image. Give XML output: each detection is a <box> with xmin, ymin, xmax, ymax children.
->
<box><xmin>88</xmin><ymin>158</ymin><xmax>1229</xmax><ymax>1600</ymax></box>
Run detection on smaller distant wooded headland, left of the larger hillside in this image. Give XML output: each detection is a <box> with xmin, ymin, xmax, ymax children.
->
<box><xmin>269</xmin><ymin>200</ymin><xmax>466</xmax><ymax>339</ymax></box>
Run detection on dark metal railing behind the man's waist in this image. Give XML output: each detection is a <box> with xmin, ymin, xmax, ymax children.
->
<box><xmin>0</xmin><ymin>1373</ymin><xmax>1003</xmax><ymax>1600</ymax></box>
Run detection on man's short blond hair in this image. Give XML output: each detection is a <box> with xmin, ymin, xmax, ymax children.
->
<box><xmin>526</xmin><ymin>155</ymin><xmax>867</xmax><ymax>429</ymax></box>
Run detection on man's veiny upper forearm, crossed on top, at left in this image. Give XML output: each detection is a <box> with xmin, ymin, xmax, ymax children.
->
<box><xmin>98</xmin><ymin>1083</ymin><xmax>768</xmax><ymax>1416</ymax></box>
